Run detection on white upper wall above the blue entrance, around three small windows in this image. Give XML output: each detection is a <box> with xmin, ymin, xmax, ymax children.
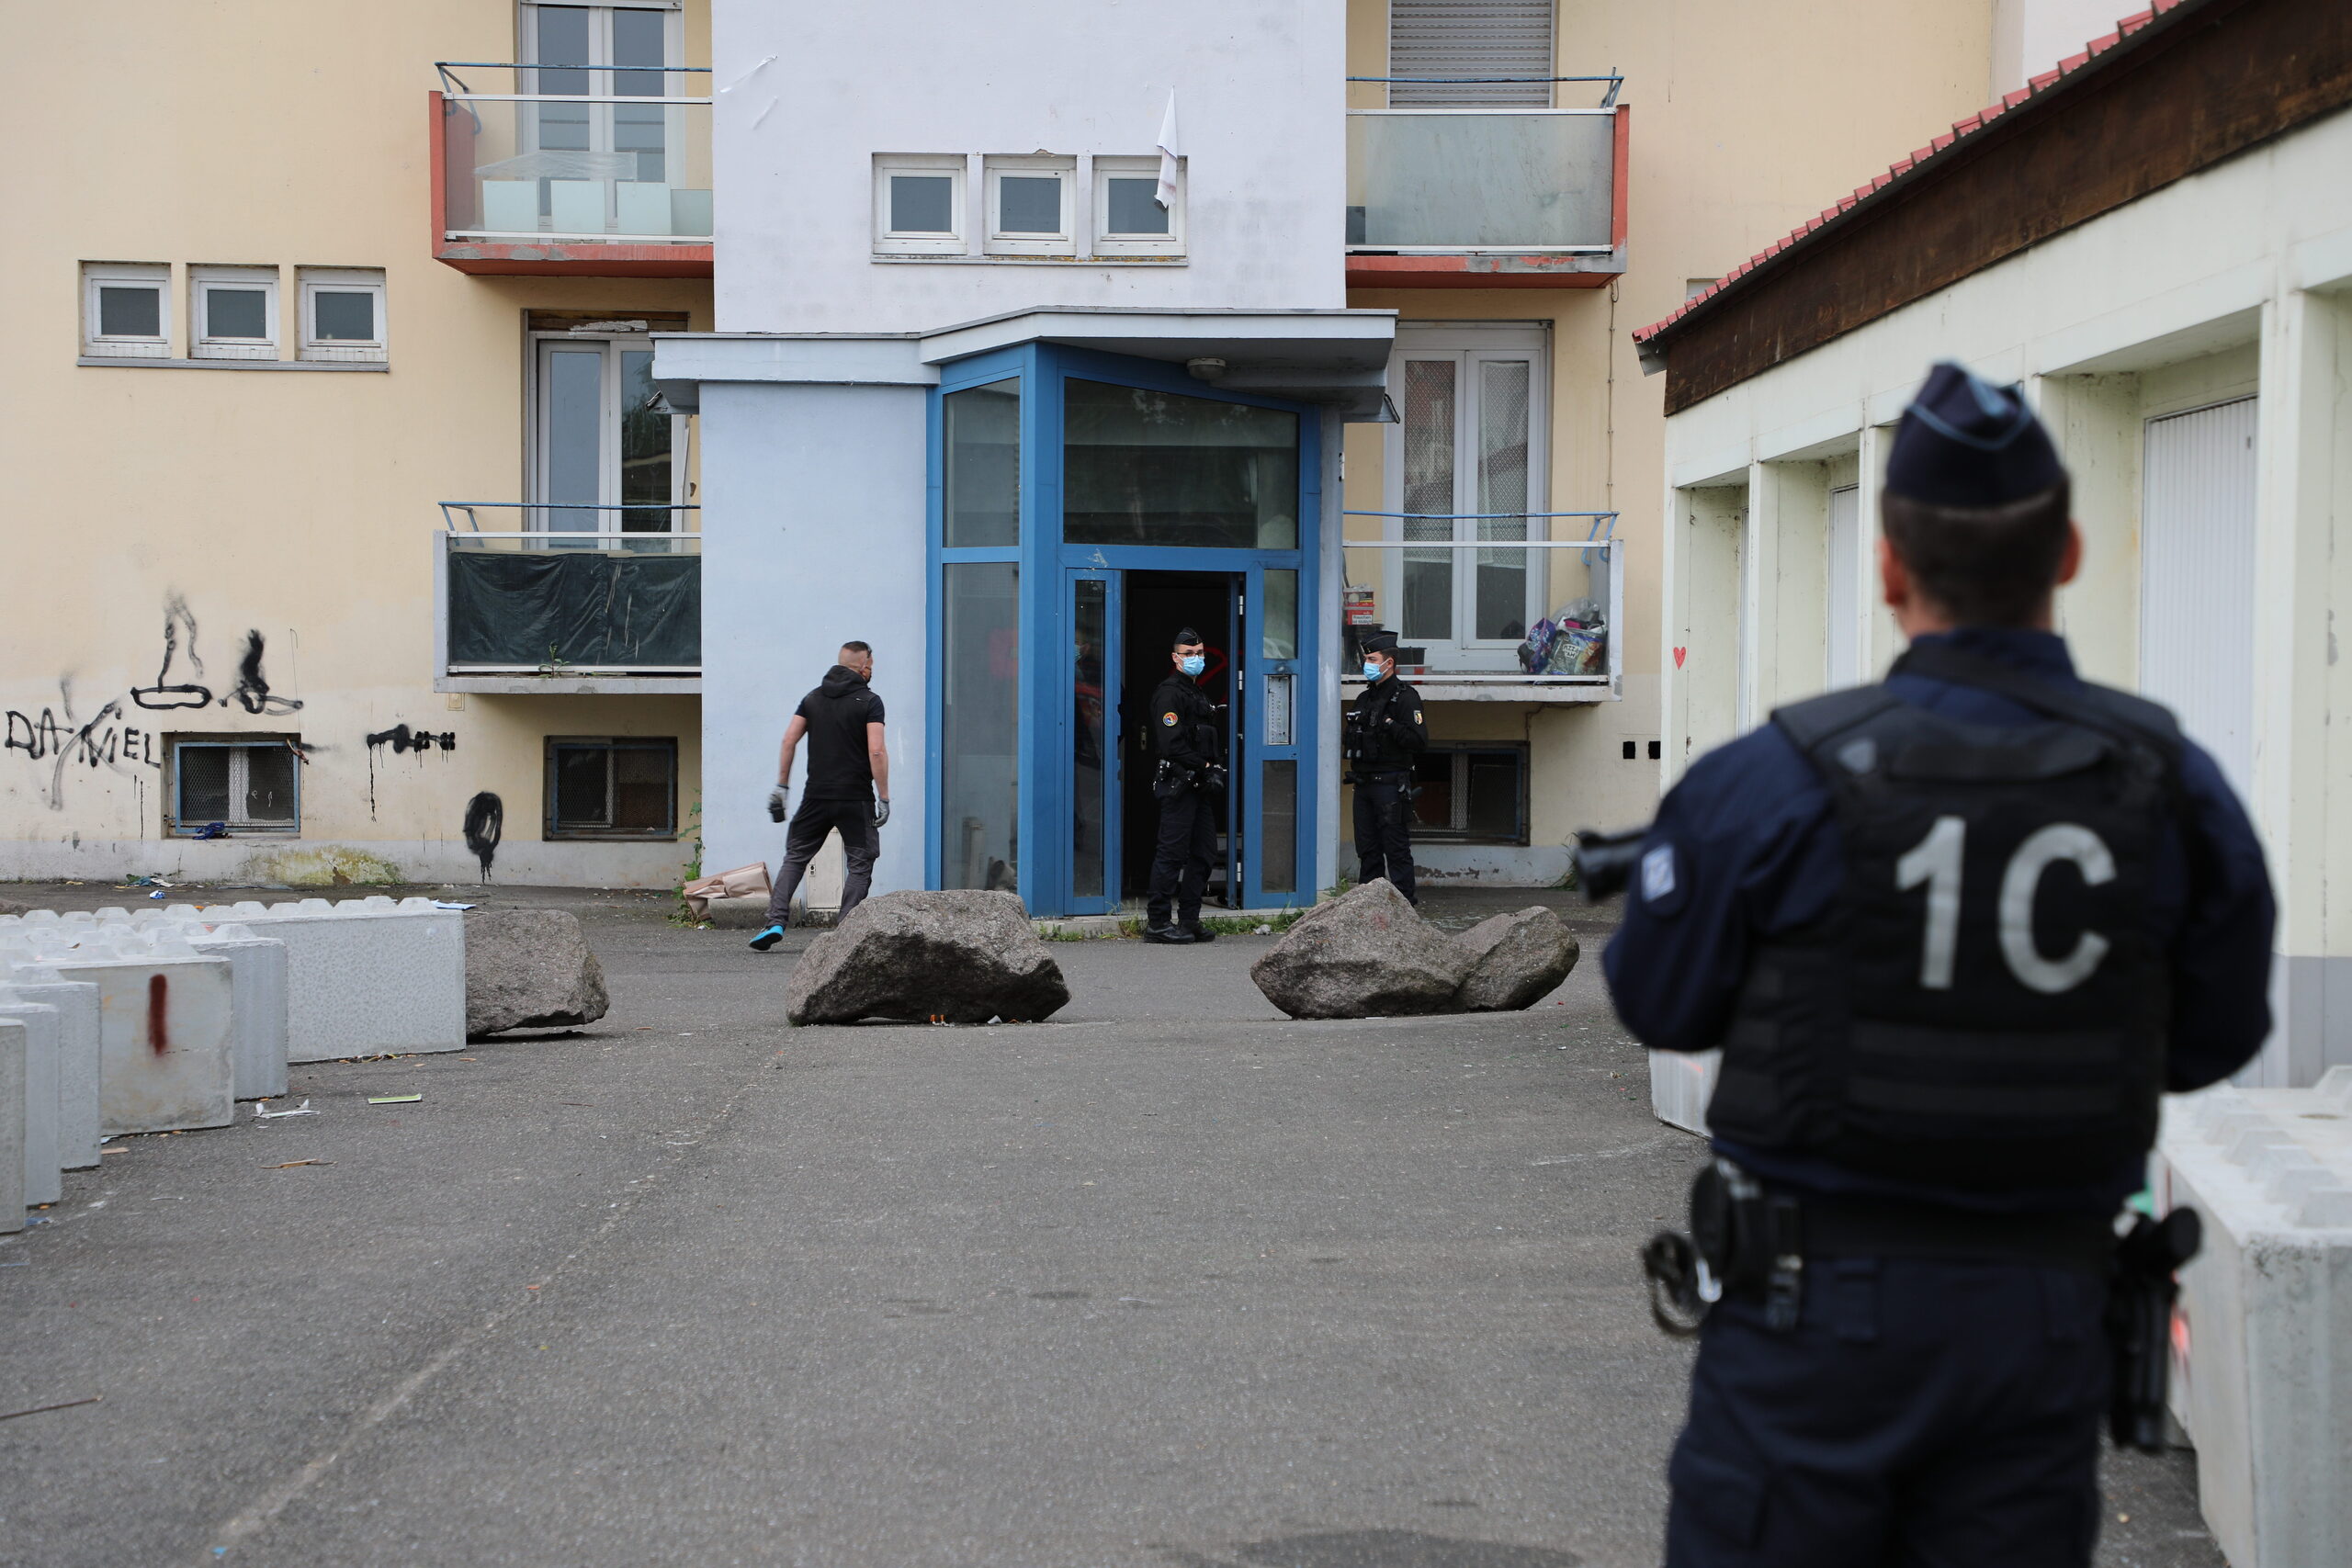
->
<box><xmin>706</xmin><ymin>0</ymin><xmax>1348</xmax><ymax>333</ymax></box>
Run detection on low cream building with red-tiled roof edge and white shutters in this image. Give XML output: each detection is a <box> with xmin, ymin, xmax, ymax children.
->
<box><xmin>1634</xmin><ymin>0</ymin><xmax>2352</xmax><ymax>1086</ymax></box>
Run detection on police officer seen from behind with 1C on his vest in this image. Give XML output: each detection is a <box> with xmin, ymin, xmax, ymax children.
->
<box><xmin>1606</xmin><ymin>365</ymin><xmax>2275</xmax><ymax>1568</ymax></box>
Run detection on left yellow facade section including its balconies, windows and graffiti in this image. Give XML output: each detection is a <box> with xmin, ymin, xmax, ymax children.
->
<box><xmin>0</xmin><ymin>0</ymin><xmax>710</xmax><ymax>886</ymax></box>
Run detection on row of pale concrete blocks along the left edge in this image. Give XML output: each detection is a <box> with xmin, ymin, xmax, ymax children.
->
<box><xmin>0</xmin><ymin>896</ymin><xmax>466</xmax><ymax>1229</ymax></box>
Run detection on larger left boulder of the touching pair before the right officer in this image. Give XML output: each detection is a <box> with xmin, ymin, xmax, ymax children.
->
<box><xmin>1249</xmin><ymin>877</ymin><xmax>1473</xmax><ymax>1018</ymax></box>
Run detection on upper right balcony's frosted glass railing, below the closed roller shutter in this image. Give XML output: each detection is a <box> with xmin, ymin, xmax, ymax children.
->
<box><xmin>1348</xmin><ymin>75</ymin><xmax>1625</xmax><ymax>256</ymax></box>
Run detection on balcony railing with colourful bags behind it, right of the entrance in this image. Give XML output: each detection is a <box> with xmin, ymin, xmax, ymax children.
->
<box><xmin>1343</xmin><ymin>513</ymin><xmax>1625</xmax><ymax>701</ymax></box>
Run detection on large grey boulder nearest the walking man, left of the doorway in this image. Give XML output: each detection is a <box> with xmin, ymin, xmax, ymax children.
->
<box><xmin>783</xmin><ymin>891</ymin><xmax>1070</xmax><ymax>1025</ymax></box>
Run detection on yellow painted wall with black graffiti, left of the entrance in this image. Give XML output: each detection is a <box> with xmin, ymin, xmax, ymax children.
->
<box><xmin>0</xmin><ymin>0</ymin><xmax>710</xmax><ymax>882</ymax></box>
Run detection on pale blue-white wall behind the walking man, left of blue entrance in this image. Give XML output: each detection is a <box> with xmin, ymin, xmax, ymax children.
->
<box><xmin>701</xmin><ymin>378</ymin><xmax>929</xmax><ymax>905</ymax></box>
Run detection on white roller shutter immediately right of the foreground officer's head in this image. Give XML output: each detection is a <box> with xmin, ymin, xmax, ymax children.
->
<box><xmin>2141</xmin><ymin>398</ymin><xmax>2256</xmax><ymax>797</ymax></box>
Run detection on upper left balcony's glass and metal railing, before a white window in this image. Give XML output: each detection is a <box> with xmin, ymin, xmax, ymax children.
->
<box><xmin>437</xmin><ymin>62</ymin><xmax>713</xmax><ymax>244</ymax></box>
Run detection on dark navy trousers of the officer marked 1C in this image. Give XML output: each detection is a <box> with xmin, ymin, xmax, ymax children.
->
<box><xmin>1665</xmin><ymin>1258</ymin><xmax>2108</xmax><ymax>1568</ymax></box>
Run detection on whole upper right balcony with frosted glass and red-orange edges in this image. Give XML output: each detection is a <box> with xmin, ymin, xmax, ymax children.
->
<box><xmin>1348</xmin><ymin>75</ymin><xmax>1630</xmax><ymax>289</ymax></box>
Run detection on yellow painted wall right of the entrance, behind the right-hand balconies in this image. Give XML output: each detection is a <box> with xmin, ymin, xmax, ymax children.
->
<box><xmin>1345</xmin><ymin>0</ymin><xmax>1992</xmax><ymax>864</ymax></box>
